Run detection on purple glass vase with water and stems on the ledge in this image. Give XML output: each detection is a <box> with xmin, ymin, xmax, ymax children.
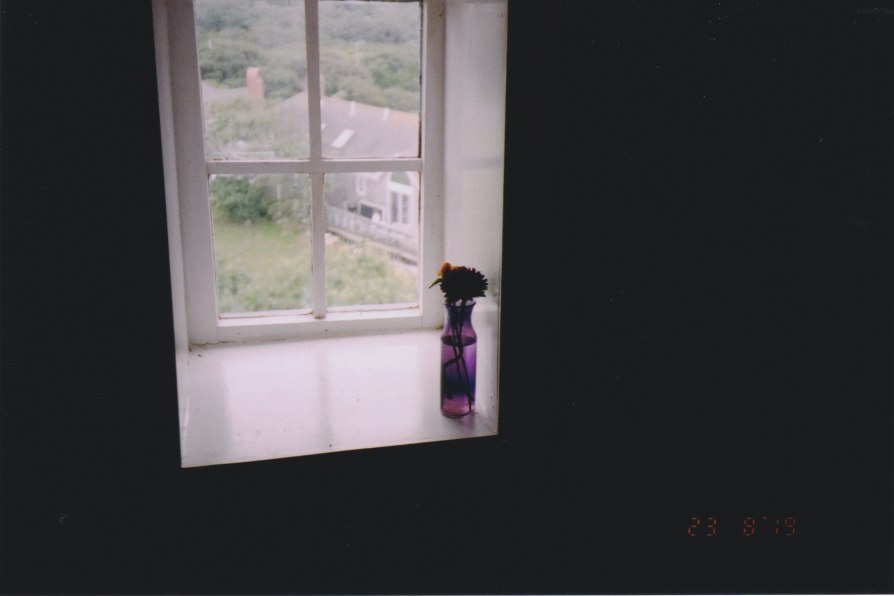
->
<box><xmin>441</xmin><ymin>301</ymin><xmax>478</xmax><ymax>418</ymax></box>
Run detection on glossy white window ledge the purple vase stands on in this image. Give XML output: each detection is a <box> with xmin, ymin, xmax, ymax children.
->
<box><xmin>178</xmin><ymin>313</ymin><xmax>498</xmax><ymax>467</ymax></box>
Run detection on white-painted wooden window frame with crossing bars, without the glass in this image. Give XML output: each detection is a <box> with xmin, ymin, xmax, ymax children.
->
<box><xmin>153</xmin><ymin>0</ymin><xmax>445</xmax><ymax>346</ymax></box>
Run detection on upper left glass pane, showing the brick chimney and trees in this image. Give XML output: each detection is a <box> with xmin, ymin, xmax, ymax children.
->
<box><xmin>195</xmin><ymin>0</ymin><xmax>310</xmax><ymax>159</ymax></box>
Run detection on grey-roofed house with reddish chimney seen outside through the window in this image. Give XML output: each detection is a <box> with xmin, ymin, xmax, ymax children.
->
<box><xmin>203</xmin><ymin>69</ymin><xmax>419</xmax><ymax>261</ymax></box>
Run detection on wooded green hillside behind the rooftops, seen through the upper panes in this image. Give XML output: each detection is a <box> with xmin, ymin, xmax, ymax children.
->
<box><xmin>196</xmin><ymin>0</ymin><xmax>421</xmax><ymax>112</ymax></box>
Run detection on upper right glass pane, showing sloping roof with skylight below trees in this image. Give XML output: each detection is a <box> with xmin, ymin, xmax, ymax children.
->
<box><xmin>320</xmin><ymin>0</ymin><xmax>422</xmax><ymax>157</ymax></box>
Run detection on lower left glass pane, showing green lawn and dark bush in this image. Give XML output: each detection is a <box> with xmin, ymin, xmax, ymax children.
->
<box><xmin>210</xmin><ymin>175</ymin><xmax>311</xmax><ymax>315</ymax></box>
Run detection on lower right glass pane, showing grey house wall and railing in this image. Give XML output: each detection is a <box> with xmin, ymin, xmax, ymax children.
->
<box><xmin>324</xmin><ymin>172</ymin><xmax>419</xmax><ymax>306</ymax></box>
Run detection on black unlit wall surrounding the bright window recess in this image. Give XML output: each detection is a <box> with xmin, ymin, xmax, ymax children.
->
<box><xmin>0</xmin><ymin>0</ymin><xmax>894</xmax><ymax>594</ymax></box>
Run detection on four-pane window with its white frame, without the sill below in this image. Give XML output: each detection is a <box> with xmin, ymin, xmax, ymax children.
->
<box><xmin>156</xmin><ymin>0</ymin><xmax>445</xmax><ymax>344</ymax></box>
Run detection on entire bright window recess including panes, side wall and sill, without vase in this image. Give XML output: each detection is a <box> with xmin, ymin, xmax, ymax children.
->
<box><xmin>153</xmin><ymin>0</ymin><xmax>506</xmax><ymax>467</ymax></box>
